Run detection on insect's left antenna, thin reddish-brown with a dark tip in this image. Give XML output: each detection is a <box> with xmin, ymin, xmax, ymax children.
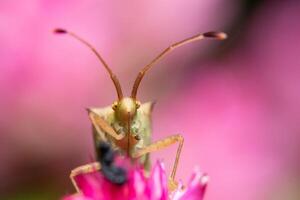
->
<box><xmin>54</xmin><ymin>28</ymin><xmax>123</xmax><ymax>100</ymax></box>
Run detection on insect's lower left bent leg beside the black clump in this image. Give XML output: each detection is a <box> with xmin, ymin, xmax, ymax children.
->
<box><xmin>70</xmin><ymin>162</ymin><xmax>101</xmax><ymax>192</ymax></box>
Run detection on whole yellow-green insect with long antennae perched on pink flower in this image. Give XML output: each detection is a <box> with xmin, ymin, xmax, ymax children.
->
<box><xmin>55</xmin><ymin>29</ymin><xmax>227</xmax><ymax>189</ymax></box>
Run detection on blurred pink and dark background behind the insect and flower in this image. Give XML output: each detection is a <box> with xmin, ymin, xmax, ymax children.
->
<box><xmin>0</xmin><ymin>0</ymin><xmax>300</xmax><ymax>200</ymax></box>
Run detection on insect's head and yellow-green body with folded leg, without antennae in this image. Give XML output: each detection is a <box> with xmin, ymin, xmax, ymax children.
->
<box><xmin>88</xmin><ymin>98</ymin><xmax>153</xmax><ymax>169</ymax></box>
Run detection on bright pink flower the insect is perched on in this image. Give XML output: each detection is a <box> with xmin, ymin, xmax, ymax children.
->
<box><xmin>63</xmin><ymin>162</ymin><xmax>207</xmax><ymax>200</ymax></box>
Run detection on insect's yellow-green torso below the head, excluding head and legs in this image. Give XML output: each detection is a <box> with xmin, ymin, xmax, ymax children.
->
<box><xmin>89</xmin><ymin>102</ymin><xmax>154</xmax><ymax>169</ymax></box>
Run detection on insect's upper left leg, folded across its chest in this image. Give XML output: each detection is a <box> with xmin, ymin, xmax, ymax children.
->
<box><xmin>88</xmin><ymin>109</ymin><xmax>125</xmax><ymax>140</ymax></box>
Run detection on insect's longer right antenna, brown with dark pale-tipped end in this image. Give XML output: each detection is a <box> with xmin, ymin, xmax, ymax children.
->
<box><xmin>131</xmin><ymin>32</ymin><xmax>227</xmax><ymax>99</ymax></box>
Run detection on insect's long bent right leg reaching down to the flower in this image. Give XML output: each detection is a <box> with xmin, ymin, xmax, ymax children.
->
<box><xmin>133</xmin><ymin>135</ymin><xmax>184</xmax><ymax>189</ymax></box>
